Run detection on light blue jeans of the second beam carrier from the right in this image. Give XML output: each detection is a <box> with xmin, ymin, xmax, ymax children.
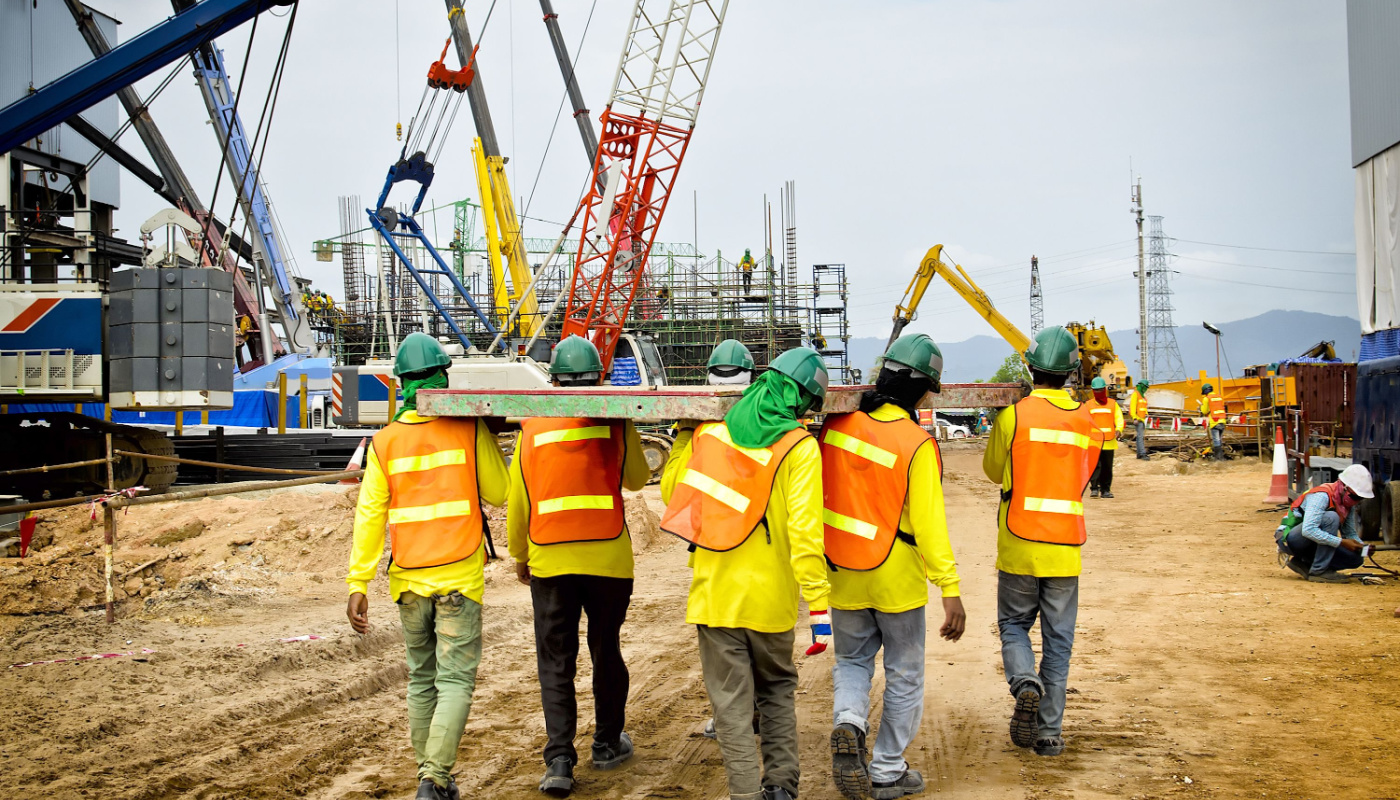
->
<box><xmin>832</xmin><ymin>607</ymin><xmax>928</xmax><ymax>783</ymax></box>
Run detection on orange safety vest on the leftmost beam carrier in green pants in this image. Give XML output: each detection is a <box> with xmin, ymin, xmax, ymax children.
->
<box><xmin>374</xmin><ymin>416</ymin><xmax>486</xmax><ymax>569</ymax></box>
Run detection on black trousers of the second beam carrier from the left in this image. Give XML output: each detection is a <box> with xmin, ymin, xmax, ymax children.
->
<box><xmin>529</xmin><ymin>574</ymin><xmax>631</xmax><ymax>764</ymax></box>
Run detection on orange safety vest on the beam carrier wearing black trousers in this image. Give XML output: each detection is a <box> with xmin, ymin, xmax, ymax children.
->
<box><xmin>519</xmin><ymin>418</ymin><xmax>626</xmax><ymax>545</ymax></box>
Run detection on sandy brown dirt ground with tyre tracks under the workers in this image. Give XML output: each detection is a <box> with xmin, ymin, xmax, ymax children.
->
<box><xmin>0</xmin><ymin>443</ymin><xmax>1400</xmax><ymax>800</ymax></box>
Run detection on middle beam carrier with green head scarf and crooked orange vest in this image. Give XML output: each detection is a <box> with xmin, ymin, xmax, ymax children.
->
<box><xmin>661</xmin><ymin>347</ymin><xmax>832</xmax><ymax>800</ymax></box>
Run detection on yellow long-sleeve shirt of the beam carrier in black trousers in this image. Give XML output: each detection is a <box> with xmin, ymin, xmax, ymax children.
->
<box><xmin>505</xmin><ymin>420</ymin><xmax>651</xmax><ymax>577</ymax></box>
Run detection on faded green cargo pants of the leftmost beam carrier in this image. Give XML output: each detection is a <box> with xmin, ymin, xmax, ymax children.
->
<box><xmin>399</xmin><ymin>591</ymin><xmax>482</xmax><ymax>787</ymax></box>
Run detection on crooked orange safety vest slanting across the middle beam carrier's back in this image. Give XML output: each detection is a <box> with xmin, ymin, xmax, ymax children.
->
<box><xmin>661</xmin><ymin>422</ymin><xmax>811</xmax><ymax>552</ymax></box>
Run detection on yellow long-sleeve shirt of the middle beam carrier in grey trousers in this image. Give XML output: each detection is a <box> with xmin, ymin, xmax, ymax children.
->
<box><xmin>661</xmin><ymin>430</ymin><xmax>832</xmax><ymax>633</ymax></box>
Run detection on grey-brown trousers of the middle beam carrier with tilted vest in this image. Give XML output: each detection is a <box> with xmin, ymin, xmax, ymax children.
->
<box><xmin>696</xmin><ymin>625</ymin><xmax>798</xmax><ymax>797</ymax></box>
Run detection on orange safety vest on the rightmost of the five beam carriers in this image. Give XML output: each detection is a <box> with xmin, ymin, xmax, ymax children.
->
<box><xmin>1002</xmin><ymin>396</ymin><xmax>1103</xmax><ymax>546</ymax></box>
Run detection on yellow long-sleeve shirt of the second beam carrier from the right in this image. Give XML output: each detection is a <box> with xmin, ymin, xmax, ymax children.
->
<box><xmin>826</xmin><ymin>404</ymin><xmax>960</xmax><ymax>614</ymax></box>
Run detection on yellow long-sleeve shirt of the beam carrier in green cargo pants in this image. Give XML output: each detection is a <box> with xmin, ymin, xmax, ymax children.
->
<box><xmin>346</xmin><ymin>411</ymin><xmax>508</xmax><ymax>602</ymax></box>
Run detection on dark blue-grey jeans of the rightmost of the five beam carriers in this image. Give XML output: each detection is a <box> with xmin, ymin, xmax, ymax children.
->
<box><xmin>997</xmin><ymin>572</ymin><xmax>1079</xmax><ymax>738</ymax></box>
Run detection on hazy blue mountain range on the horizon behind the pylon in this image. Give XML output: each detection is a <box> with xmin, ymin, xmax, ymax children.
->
<box><xmin>850</xmin><ymin>311</ymin><xmax>1361</xmax><ymax>384</ymax></box>
